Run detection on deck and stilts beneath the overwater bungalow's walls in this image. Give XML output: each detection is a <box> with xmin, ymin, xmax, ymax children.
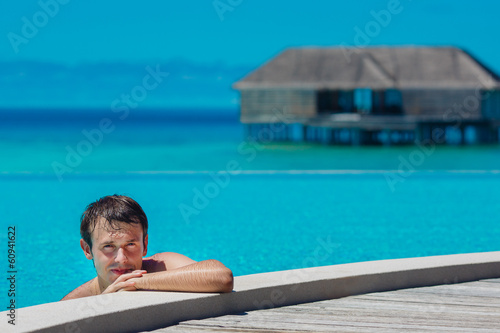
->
<box><xmin>241</xmin><ymin>113</ymin><xmax>500</xmax><ymax>145</ymax></box>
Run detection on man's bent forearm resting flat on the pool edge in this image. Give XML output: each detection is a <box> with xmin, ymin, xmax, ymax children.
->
<box><xmin>134</xmin><ymin>260</ymin><xmax>233</xmax><ymax>292</ymax></box>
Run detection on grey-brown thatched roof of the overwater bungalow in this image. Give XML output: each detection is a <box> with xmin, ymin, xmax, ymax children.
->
<box><xmin>234</xmin><ymin>47</ymin><xmax>500</xmax><ymax>89</ymax></box>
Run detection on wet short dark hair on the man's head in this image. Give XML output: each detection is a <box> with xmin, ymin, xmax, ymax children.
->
<box><xmin>80</xmin><ymin>194</ymin><xmax>148</xmax><ymax>250</ymax></box>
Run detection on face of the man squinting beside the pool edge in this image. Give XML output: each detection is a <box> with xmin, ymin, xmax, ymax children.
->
<box><xmin>82</xmin><ymin>219</ymin><xmax>148</xmax><ymax>288</ymax></box>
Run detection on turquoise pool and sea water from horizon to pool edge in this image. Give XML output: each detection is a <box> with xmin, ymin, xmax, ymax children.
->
<box><xmin>0</xmin><ymin>112</ymin><xmax>500</xmax><ymax>307</ymax></box>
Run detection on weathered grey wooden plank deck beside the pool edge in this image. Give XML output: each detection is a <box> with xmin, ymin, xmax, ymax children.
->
<box><xmin>153</xmin><ymin>279</ymin><xmax>500</xmax><ymax>333</ymax></box>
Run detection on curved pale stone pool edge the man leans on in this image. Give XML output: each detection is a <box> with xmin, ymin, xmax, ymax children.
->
<box><xmin>0</xmin><ymin>251</ymin><xmax>500</xmax><ymax>333</ymax></box>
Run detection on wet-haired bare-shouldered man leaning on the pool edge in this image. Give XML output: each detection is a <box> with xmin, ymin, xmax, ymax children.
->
<box><xmin>62</xmin><ymin>195</ymin><xmax>233</xmax><ymax>300</ymax></box>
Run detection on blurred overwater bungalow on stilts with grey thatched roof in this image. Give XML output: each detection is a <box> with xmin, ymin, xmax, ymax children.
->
<box><xmin>234</xmin><ymin>46</ymin><xmax>500</xmax><ymax>144</ymax></box>
